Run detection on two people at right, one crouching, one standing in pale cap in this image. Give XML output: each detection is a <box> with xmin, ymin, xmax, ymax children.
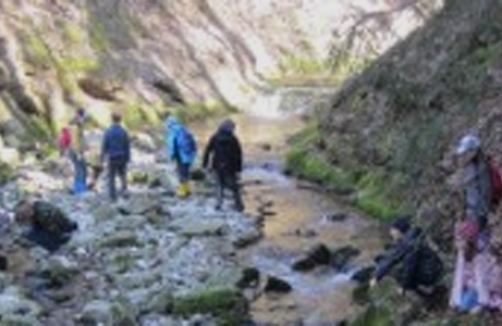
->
<box><xmin>370</xmin><ymin>135</ymin><xmax>502</xmax><ymax>313</ymax></box>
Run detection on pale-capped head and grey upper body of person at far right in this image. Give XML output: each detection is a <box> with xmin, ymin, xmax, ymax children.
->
<box><xmin>456</xmin><ymin>134</ymin><xmax>492</xmax><ymax>246</ymax></box>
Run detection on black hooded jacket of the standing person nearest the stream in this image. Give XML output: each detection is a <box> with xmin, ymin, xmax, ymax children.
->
<box><xmin>203</xmin><ymin>122</ymin><xmax>242</xmax><ymax>174</ymax></box>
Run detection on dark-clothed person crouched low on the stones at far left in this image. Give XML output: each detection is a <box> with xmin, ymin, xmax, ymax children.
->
<box><xmin>15</xmin><ymin>200</ymin><xmax>78</xmax><ymax>252</ymax></box>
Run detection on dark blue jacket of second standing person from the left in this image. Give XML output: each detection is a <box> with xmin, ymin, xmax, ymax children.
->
<box><xmin>101</xmin><ymin>124</ymin><xmax>131</xmax><ymax>162</ymax></box>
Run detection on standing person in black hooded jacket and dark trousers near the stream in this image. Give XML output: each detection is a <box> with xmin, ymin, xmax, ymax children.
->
<box><xmin>203</xmin><ymin>119</ymin><xmax>244</xmax><ymax>211</ymax></box>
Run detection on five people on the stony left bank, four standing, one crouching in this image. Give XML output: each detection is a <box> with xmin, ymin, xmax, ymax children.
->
<box><xmin>15</xmin><ymin>109</ymin><xmax>244</xmax><ymax>252</ymax></box>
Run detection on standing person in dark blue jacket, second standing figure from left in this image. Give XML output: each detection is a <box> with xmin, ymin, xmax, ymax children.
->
<box><xmin>101</xmin><ymin>113</ymin><xmax>131</xmax><ymax>201</ymax></box>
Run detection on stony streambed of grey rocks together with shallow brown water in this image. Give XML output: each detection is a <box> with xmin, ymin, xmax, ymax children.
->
<box><xmin>0</xmin><ymin>113</ymin><xmax>381</xmax><ymax>326</ymax></box>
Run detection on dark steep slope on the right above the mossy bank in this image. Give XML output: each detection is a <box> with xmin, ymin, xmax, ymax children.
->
<box><xmin>316</xmin><ymin>0</ymin><xmax>502</xmax><ymax>227</ymax></box>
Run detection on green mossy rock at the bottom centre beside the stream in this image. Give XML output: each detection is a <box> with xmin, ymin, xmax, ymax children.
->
<box><xmin>172</xmin><ymin>289</ymin><xmax>248</xmax><ymax>326</ymax></box>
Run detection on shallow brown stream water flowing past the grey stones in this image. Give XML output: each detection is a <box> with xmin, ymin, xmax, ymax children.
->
<box><xmin>193</xmin><ymin>115</ymin><xmax>382</xmax><ymax>325</ymax></box>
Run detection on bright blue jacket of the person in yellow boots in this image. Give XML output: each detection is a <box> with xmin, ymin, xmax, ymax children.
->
<box><xmin>165</xmin><ymin>117</ymin><xmax>197</xmax><ymax>164</ymax></box>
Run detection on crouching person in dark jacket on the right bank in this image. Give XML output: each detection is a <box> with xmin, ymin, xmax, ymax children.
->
<box><xmin>370</xmin><ymin>217</ymin><xmax>443</xmax><ymax>296</ymax></box>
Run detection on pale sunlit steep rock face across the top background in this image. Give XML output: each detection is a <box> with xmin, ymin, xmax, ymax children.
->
<box><xmin>0</xmin><ymin>0</ymin><xmax>441</xmax><ymax>142</ymax></box>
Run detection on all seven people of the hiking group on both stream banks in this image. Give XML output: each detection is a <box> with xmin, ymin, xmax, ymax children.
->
<box><xmin>5</xmin><ymin>109</ymin><xmax>502</xmax><ymax>313</ymax></box>
